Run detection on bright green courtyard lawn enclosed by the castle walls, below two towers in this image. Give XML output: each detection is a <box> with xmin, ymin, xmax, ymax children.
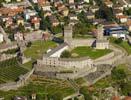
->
<box><xmin>71</xmin><ymin>46</ymin><xmax>112</xmax><ymax>59</ymax></box>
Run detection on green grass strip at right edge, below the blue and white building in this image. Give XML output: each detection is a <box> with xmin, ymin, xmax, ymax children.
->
<box><xmin>110</xmin><ymin>38</ymin><xmax>131</xmax><ymax>55</ymax></box>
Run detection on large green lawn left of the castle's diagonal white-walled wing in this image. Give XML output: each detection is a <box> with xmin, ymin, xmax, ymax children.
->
<box><xmin>24</xmin><ymin>40</ymin><xmax>57</xmax><ymax>59</ymax></box>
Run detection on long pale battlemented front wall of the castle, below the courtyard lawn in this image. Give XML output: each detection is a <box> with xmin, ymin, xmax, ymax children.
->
<box><xmin>37</xmin><ymin>57</ymin><xmax>93</xmax><ymax>69</ymax></box>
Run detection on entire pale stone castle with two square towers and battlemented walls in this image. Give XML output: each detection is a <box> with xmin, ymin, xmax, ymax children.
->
<box><xmin>35</xmin><ymin>26</ymin><xmax>109</xmax><ymax>78</ymax></box>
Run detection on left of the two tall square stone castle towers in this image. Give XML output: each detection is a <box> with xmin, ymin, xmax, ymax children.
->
<box><xmin>64</xmin><ymin>26</ymin><xmax>73</xmax><ymax>45</ymax></box>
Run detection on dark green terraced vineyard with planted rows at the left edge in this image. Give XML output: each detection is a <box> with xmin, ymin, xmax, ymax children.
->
<box><xmin>0</xmin><ymin>58</ymin><xmax>28</xmax><ymax>83</ymax></box>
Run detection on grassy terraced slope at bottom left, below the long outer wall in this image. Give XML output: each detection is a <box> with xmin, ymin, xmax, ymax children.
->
<box><xmin>0</xmin><ymin>78</ymin><xmax>75</xmax><ymax>100</ymax></box>
